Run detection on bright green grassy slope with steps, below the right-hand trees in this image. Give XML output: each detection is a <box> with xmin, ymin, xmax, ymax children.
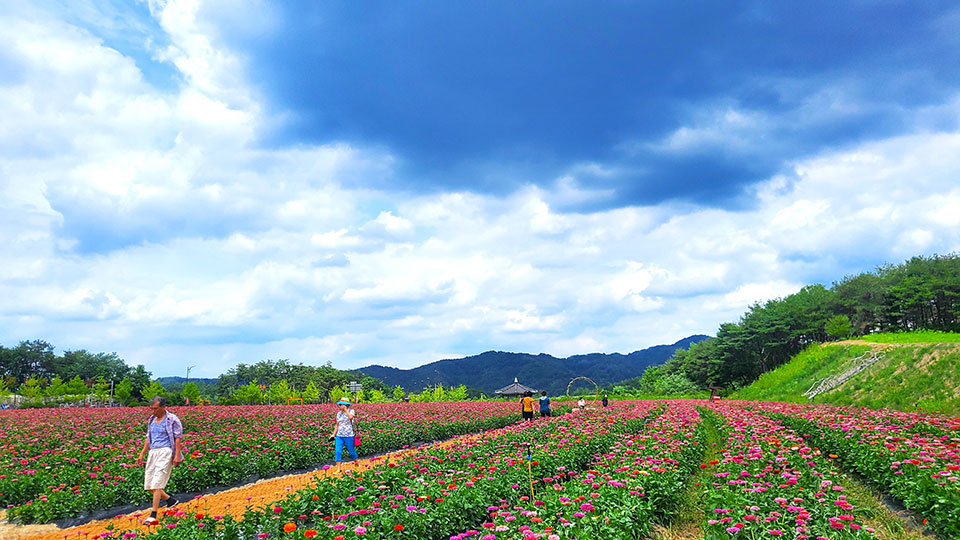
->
<box><xmin>730</xmin><ymin>332</ymin><xmax>960</xmax><ymax>415</ymax></box>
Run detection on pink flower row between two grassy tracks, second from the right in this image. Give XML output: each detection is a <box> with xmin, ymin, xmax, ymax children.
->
<box><xmin>704</xmin><ymin>403</ymin><xmax>875</xmax><ymax>540</ymax></box>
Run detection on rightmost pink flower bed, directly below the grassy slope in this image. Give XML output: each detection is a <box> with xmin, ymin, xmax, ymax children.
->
<box><xmin>756</xmin><ymin>403</ymin><xmax>960</xmax><ymax>538</ymax></box>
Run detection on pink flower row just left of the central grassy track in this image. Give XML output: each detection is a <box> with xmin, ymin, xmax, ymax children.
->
<box><xmin>450</xmin><ymin>402</ymin><xmax>703</xmax><ymax>540</ymax></box>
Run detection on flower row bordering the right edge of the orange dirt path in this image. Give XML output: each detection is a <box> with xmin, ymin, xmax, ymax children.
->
<box><xmin>99</xmin><ymin>402</ymin><xmax>668</xmax><ymax>540</ymax></box>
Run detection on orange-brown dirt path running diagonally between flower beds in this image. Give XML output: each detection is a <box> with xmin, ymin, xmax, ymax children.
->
<box><xmin>0</xmin><ymin>433</ymin><xmax>484</xmax><ymax>540</ymax></box>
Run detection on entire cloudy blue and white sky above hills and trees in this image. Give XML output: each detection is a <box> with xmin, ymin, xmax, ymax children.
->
<box><xmin>0</xmin><ymin>0</ymin><xmax>960</xmax><ymax>377</ymax></box>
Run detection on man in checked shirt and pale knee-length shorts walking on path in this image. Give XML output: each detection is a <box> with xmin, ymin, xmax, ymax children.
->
<box><xmin>137</xmin><ymin>396</ymin><xmax>183</xmax><ymax>525</ymax></box>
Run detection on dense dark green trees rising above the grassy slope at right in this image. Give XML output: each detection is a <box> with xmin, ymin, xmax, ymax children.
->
<box><xmin>621</xmin><ymin>254</ymin><xmax>960</xmax><ymax>393</ymax></box>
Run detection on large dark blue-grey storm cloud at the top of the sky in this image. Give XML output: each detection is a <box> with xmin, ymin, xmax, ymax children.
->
<box><xmin>226</xmin><ymin>2</ymin><xmax>960</xmax><ymax>206</ymax></box>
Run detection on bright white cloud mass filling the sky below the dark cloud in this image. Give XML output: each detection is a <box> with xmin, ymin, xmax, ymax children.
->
<box><xmin>0</xmin><ymin>1</ymin><xmax>960</xmax><ymax>376</ymax></box>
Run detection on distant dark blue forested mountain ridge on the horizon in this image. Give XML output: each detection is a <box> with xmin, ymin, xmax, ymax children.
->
<box><xmin>358</xmin><ymin>335</ymin><xmax>708</xmax><ymax>395</ymax></box>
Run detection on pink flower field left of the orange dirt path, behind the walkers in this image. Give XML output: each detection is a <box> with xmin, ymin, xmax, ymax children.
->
<box><xmin>0</xmin><ymin>402</ymin><xmax>519</xmax><ymax>523</ymax></box>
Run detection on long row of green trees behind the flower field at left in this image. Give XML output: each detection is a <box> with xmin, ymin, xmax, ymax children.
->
<box><xmin>0</xmin><ymin>340</ymin><xmax>473</xmax><ymax>407</ymax></box>
